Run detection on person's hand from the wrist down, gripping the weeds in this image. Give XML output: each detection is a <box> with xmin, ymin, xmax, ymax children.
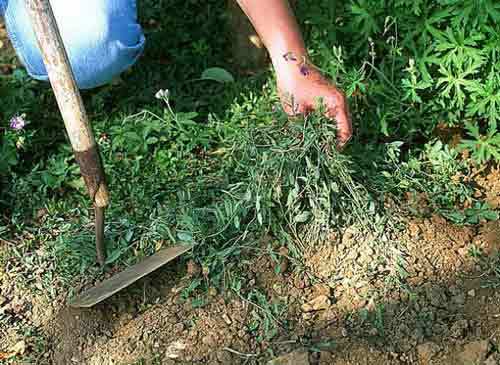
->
<box><xmin>276</xmin><ymin>54</ymin><xmax>352</xmax><ymax>148</ymax></box>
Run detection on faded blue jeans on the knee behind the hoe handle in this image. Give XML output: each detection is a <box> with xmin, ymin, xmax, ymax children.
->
<box><xmin>0</xmin><ymin>0</ymin><xmax>145</xmax><ymax>89</ymax></box>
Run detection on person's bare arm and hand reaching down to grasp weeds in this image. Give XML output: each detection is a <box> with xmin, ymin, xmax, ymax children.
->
<box><xmin>237</xmin><ymin>0</ymin><xmax>352</xmax><ymax>146</ymax></box>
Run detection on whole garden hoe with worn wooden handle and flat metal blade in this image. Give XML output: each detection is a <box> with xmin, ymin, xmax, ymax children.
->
<box><xmin>26</xmin><ymin>0</ymin><xmax>192</xmax><ymax>308</ymax></box>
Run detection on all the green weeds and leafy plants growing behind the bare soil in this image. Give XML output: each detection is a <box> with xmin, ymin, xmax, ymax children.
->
<box><xmin>0</xmin><ymin>0</ymin><xmax>500</xmax><ymax>296</ymax></box>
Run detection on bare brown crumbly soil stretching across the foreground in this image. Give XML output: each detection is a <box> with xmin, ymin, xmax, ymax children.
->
<box><xmin>0</xmin><ymin>169</ymin><xmax>500</xmax><ymax>365</ymax></box>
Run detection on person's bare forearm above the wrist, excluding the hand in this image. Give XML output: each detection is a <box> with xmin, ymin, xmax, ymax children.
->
<box><xmin>237</xmin><ymin>0</ymin><xmax>307</xmax><ymax>70</ymax></box>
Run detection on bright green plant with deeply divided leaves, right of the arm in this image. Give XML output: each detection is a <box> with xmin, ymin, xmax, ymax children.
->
<box><xmin>298</xmin><ymin>0</ymin><xmax>500</xmax><ymax>163</ymax></box>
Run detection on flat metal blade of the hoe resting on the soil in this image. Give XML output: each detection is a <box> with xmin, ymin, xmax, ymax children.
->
<box><xmin>69</xmin><ymin>245</ymin><xmax>193</xmax><ymax>308</ymax></box>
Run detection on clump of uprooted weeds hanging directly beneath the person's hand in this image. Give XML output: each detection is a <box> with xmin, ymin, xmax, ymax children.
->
<box><xmin>226</xmin><ymin>106</ymin><xmax>370</xmax><ymax>244</ymax></box>
